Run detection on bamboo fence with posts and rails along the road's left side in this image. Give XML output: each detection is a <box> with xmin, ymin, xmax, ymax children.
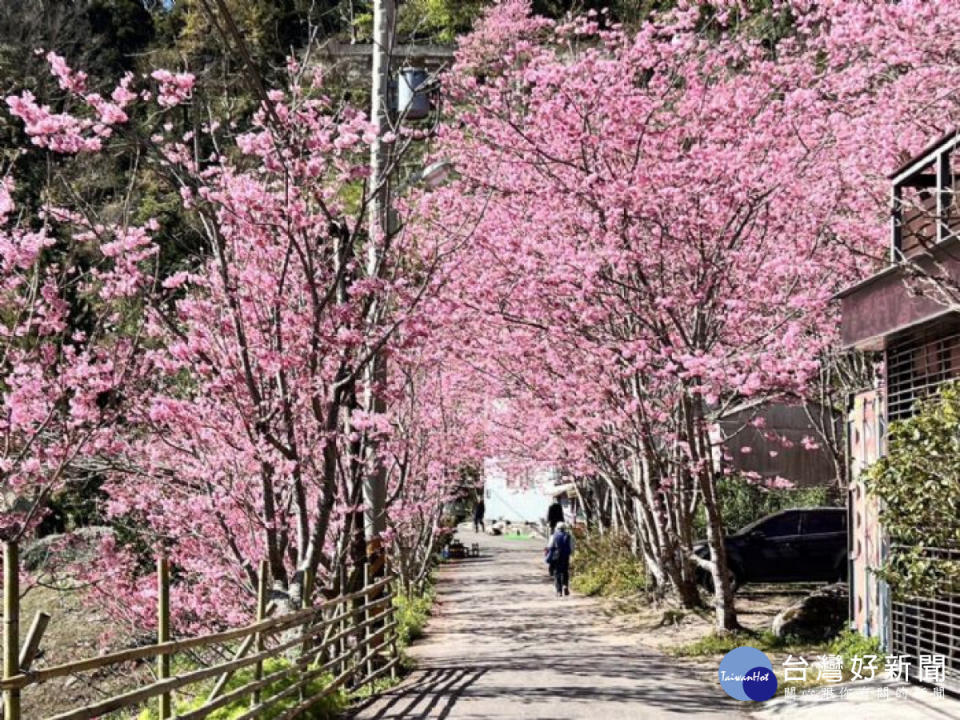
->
<box><xmin>0</xmin><ymin>543</ymin><xmax>400</xmax><ymax>720</ymax></box>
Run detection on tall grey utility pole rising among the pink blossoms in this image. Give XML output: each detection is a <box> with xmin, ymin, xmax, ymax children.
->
<box><xmin>363</xmin><ymin>0</ymin><xmax>396</xmax><ymax>578</ymax></box>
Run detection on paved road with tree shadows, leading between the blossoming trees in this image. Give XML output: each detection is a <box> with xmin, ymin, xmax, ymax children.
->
<box><xmin>353</xmin><ymin>531</ymin><xmax>745</xmax><ymax>720</ymax></box>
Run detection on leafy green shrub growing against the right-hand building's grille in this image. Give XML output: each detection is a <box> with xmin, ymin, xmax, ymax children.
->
<box><xmin>864</xmin><ymin>381</ymin><xmax>960</xmax><ymax>597</ymax></box>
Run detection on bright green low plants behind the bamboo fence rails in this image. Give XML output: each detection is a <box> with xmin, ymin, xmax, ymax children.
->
<box><xmin>137</xmin><ymin>658</ymin><xmax>348</xmax><ymax>720</ymax></box>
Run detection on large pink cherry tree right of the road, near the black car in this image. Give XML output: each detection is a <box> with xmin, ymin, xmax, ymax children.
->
<box><xmin>414</xmin><ymin>2</ymin><xmax>876</xmax><ymax>630</ymax></box>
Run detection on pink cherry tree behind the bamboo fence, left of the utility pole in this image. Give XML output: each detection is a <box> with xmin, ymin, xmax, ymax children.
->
<box><xmin>8</xmin><ymin>43</ymin><xmax>455</xmax><ymax>627</ymax></box>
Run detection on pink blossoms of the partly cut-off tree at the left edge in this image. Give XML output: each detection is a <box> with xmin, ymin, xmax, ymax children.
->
<box><xmin>0</xmin><ymin>178</ymin><xmax>152</xmax><ymax>539</ymax></box>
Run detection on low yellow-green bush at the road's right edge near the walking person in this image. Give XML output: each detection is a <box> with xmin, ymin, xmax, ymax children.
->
<box><xmin>570</xmin><ymin>532</ymin><xmax>647</xmax><ymax>597</ymax></box>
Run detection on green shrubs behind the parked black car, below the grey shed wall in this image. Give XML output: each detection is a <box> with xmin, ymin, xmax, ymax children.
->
<box><xmin>694</xmin><ymin>476</ymin><xmax>835</xmax><ymax>537</ymax></box>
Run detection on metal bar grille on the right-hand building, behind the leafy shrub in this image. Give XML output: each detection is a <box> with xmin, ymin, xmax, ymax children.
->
<box><xmin>886</xmin><ymin>320</ymin><xmax>960</xmax><ymax>691</ymax></box>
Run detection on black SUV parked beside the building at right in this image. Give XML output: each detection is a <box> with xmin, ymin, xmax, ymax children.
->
<box><xmin>694</xmin><ymin>508</ymin><xmax>847</xmax><ymax>587</ymax></box>
